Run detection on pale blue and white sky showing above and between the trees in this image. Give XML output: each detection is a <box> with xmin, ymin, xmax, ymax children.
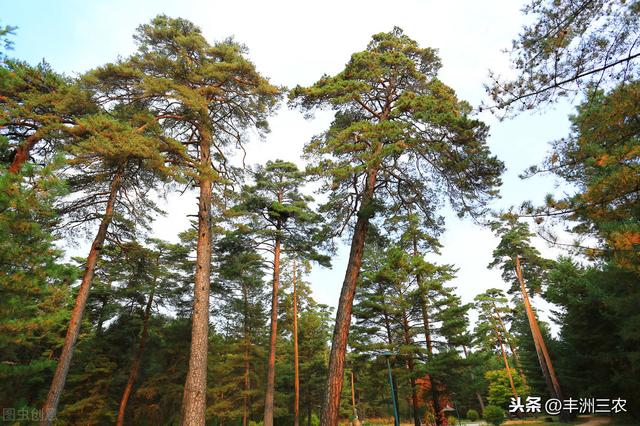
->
<box><xmin>0</xmin><ymin>0</ymin><xmax>571</xmax><ymax>330</ymax></box>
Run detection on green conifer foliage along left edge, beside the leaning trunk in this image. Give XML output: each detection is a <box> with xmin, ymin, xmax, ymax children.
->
<box><xmin>0</xmin><ymin>163</ymin><xmax>77</xmax><ymax>409</ymax></box>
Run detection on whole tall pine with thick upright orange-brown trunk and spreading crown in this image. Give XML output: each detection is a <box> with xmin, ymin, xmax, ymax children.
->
<box><xmin>85</xmin><ymin>15</ymin><xmax>279</xmax><ymax>424</ymax></box>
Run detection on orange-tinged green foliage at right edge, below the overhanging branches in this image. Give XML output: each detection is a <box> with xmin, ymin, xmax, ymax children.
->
<box><xmin>532</xmin><ymin>82</ymin><xmax>640</xmax><ymax>272</ymax></box>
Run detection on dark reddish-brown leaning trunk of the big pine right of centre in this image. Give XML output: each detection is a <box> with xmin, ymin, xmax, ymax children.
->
<box><xmin>320</xmin><ymin>161</ymin><xmax>382</xmax><ymax>426</ymax></box>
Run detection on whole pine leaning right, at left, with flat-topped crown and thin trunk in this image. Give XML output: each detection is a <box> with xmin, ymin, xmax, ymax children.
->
<box><xmin>42</xmin><ymin>108</ymin><xmax>180</xmax><ymax>425</ymax></box>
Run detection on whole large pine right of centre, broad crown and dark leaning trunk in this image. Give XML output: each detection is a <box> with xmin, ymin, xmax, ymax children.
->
<box><xmin>290</xmin><ymin>28</ymin><xmax>503</xmax><ymax>426</ymax></box>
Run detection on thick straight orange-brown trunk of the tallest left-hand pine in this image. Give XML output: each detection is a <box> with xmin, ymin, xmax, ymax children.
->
<box><xmin>182</xmin><ymin>134</ymin><xmax>211</xmax><ymax>426</ymax></box>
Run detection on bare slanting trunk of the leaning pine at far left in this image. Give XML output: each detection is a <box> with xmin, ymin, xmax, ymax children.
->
<box><xmin>40</xmin><ymin>164</ymin><xmax>125</xmax><ymax>426</ymax></box>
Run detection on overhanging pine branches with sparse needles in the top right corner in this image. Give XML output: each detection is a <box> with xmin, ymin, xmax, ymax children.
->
<box><xmin>487</xmin><ymin>0</ymin><xmax>640</xmax><ymax>111</ymax></box>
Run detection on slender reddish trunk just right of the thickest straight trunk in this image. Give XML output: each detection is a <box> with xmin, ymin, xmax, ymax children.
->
<box><xmin>264</xmin><ymin>236</ymin><xmax>280</xmax><ymax>426</ymax></box>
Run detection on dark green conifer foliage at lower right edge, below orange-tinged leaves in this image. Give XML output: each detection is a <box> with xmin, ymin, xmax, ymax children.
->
<box><xmin>547</xmin><ymin>258</ymin><xmax>640</xmax><ymax>418</ymax></box>
